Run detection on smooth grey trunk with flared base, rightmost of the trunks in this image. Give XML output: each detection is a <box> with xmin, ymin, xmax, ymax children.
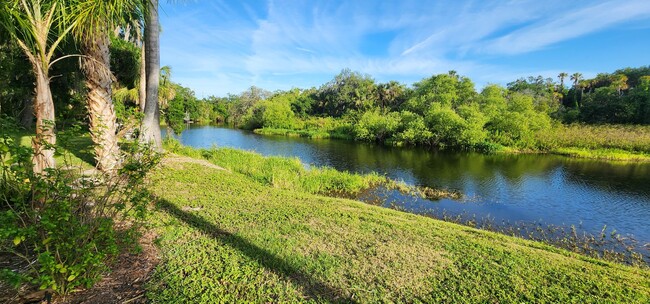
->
<box><xmin>140</xmin><ymin>0</ymin><xmax>162</xmax><ymax>151</ymax></box>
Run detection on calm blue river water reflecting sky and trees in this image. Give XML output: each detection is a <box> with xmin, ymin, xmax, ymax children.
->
<box><xmin>165</xmin><ymin>126</ymin><xmax>650</xmax><ymax>245</ymax></box>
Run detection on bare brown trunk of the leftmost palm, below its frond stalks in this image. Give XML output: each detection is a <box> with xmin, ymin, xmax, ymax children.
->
<box><xmin>32</xmin><ymin>63</ymin><xmax>56</xmax><ymax>174</ymax></box>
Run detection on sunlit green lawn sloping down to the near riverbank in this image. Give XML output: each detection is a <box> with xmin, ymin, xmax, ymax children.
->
<box><xmin>148</xmin><ymin>156</ymin><xmax>650</xmax><ymax>303</ymax></box>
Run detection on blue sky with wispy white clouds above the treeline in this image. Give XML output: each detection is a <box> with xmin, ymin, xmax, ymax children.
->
<box><xmin>161</xmin><ymin>0</ymin><xmax>650</xmax><ymax>97</ymax></box>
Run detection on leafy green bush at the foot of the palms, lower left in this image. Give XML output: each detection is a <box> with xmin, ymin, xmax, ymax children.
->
<box><xmin>0</xmin><ymin>126</ymin><xmax>159</xmax><ymax>293</ymax></box>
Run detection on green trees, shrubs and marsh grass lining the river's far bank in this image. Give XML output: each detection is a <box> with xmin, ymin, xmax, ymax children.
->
<box><xmin>156</xmin><ymin>66</ymin><xmax>650</xmax><ymax>162</ymax></box>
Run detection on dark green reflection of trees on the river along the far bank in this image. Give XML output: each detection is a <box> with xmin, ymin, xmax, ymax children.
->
<box><xmin>304</xmin><ymin>140</ymin><xmax>650</xmax><ymax>201</ymax></box>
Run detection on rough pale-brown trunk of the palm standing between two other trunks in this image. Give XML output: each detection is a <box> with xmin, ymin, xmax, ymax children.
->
<box><xmin>82</xmin><ymin>31</ymin><xmax>120</xmax><ymax>173</ymax></box>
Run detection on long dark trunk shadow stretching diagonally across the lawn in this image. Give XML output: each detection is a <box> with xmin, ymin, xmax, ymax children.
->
<box><xmin>158</xmin><ymin>200</ymin><xmax>356</xmax><ymax>303</ymax></box>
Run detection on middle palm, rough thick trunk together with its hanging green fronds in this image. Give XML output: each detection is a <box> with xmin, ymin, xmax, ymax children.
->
<box><xmin>73</xmin><ymin>0</ymin><xmax>142</xmax><ymax>173</ymax></box>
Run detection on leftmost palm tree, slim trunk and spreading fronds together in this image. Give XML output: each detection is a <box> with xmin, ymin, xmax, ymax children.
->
<box><xmin>0</xmin><ymin>0</ymin><xmax>73</xmax><ymax>174</ymax></box>
